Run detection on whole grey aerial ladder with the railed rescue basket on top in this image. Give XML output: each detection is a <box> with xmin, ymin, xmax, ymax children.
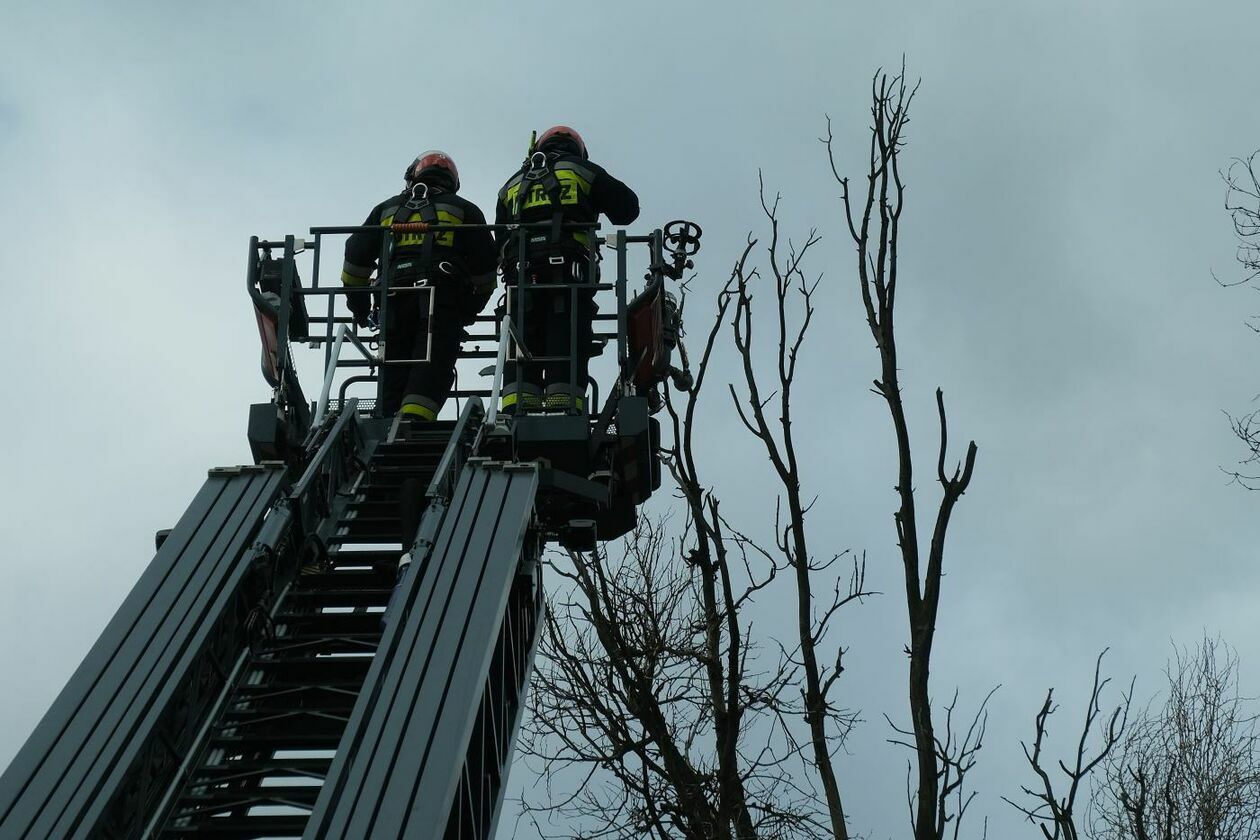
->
<box><xmin>0</xmin><ymin>214</ymin><xmax>701</xmax><ymax>840</ymax></box>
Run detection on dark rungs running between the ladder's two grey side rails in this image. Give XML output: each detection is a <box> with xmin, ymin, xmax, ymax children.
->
<box><xmin>158</xmin><ymin>423</ymin><xmax>454</xmax><ymax>837</ymax></box>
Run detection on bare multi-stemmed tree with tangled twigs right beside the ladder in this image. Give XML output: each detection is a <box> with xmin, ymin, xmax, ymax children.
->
<box><xmin>524</xmin><ymin>195</ymin><xmax>871</xmax><ymax>840</ymax></box>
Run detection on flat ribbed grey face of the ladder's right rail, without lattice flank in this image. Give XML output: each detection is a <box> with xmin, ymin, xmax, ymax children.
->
<box><xmin>304</xmin><ymin>462</ymin><xmax>538</xmax><ymax>840</ymax></box>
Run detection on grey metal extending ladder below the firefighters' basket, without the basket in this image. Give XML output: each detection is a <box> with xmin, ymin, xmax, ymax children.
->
<box><xmin>0</xmin><ymin>400</ymin><xmax>542</xmax><ymax>840</ymax></box>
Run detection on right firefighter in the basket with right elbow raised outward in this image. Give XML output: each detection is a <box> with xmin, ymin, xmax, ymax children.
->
<box><xmin>494</xmin><ymin>126</ymin><xmax>639</xmax><ymax>412</ymax></box>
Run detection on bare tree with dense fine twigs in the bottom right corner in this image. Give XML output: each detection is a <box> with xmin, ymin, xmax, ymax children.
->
<box><xmin>1092</xmin><ymin>637</ymin><xmax>1260</xmax><ymax>840</ymax></box>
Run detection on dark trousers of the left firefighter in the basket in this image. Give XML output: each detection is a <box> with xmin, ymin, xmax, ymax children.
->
<box><xmin>381</xmin><ymin>276</ymin><xmax>475</xmax><ymax>419</ymax></box>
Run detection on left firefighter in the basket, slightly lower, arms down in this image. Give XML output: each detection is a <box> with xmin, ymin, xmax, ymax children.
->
<box><xmin>341</xmin><ymin>151</ymin><xmax>496</xmax><ymax>421</ymax></box>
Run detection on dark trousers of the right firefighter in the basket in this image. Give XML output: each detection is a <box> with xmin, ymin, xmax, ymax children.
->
<box><xmin>504</xmin><ymin>257</ymin><xmax>599</xmax><ymax>397</ymax></box>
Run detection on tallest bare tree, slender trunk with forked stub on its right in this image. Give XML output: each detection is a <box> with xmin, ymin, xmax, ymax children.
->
<box><xmin>823</xmin><ymin>65</ymin><xmax>977</xmax><ymax>840</ymax></box>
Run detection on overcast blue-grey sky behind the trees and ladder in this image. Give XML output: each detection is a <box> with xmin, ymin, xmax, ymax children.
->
<box><xmin>0</xmin><ymin>0</ymin><xmax>1260</xmax><ymax>839</ymax></box>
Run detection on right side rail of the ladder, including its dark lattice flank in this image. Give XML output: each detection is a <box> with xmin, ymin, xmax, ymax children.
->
<box><xmin>304</xmin><ymin>462</ymin><xmax>543</xmax><ymax>840</ymax></box>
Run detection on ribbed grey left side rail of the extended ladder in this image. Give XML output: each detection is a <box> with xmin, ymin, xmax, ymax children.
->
<box><xmin>0</xmin><ymin>465</ymin><xmax>295</xmax><ymax>840</ymax></box>
